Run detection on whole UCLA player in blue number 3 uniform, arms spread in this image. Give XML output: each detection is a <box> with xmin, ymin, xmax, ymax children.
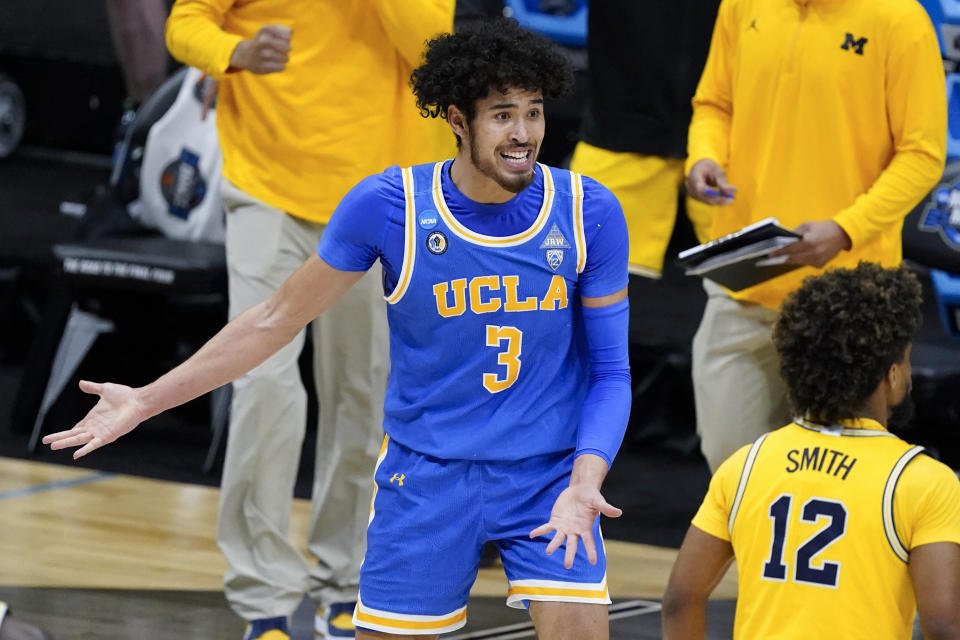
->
<box><xmin>45</xmin><ymin>20</ymin><xmax>630</xmax><ymax>640</ymax></box>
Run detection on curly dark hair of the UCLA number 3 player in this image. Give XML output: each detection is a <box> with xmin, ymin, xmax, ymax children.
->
<box><xmin>410</xmin><ymin>18</ymin><xmax>573</xmax><ymax>122</ymax></box>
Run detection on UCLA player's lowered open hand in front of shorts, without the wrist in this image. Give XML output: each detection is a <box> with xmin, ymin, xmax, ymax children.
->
<box><xmin>530</xmin><ymin>484</ymin><xmax>623</xmax><ymax>569</ymax></box>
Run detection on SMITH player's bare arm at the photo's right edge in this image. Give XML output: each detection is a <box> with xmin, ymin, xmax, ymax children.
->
<box><xmin>910</xmin><ymin>542</ymin><xmax>960</xmax><ymax>640</ymax></box>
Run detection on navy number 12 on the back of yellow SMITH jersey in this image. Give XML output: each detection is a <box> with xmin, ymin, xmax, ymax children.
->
<box><xmin>763</xmin><ymin>493</ymin><xmax>847</xmax><ymax>587</ymax></box>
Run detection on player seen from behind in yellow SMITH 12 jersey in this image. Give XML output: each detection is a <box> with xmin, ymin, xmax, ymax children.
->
<box><xmin>663</xmin><ymin>262</ymin><xmax>960</xmax><ymax>640</ymax></box>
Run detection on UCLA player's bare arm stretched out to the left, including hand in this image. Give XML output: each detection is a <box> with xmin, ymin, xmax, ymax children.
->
<box><xmin>43</xmin><ymin>256</ymin><xmax>363</xmax><ymax>459</ymax></box>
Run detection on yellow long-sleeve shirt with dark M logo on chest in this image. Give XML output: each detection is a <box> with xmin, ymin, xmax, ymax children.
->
<box><xmin>687</xmin><ymin>0</ymin><xmax>946</xmax><ymax>308</ymax></box>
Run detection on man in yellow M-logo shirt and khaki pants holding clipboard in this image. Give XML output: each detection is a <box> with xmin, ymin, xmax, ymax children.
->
<box><xmin>687</xmin><ymin>0</ymin><xmax>946</xmax><ymax>470</ymax></box>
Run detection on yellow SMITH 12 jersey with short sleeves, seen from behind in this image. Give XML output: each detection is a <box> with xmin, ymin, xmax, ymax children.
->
<box><xmin>693</xmin><ymin>418</ymin><xmax>960</xmax><ymax>640</ymax></box>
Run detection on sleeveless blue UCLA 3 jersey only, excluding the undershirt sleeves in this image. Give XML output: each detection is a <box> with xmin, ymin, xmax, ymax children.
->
<box><xmin>384</xmin><ymin>163</ymin><xmax>587</xmax><ymax>460</ymax></box>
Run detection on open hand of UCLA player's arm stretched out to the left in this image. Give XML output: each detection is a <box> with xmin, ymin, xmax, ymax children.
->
<box><xmin>43</xmin><ymin>380</ymin><xmax>148</xmax><ymax>460</ymax></box>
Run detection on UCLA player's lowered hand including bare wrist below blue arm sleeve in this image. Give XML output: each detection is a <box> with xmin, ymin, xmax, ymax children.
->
<box><xmin>530</xmin><ymin>453</ymin><xmax>623</xmax><ymax>569</ymax></box>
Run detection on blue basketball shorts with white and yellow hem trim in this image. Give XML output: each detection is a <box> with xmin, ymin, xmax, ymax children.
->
<box><xmin>354</xmin><ymin>438</ymin><xmax>610</xmax><ymax>635</ymax></box>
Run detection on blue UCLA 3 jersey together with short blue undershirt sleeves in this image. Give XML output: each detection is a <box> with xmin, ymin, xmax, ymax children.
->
<box><xmin>317</xmin><ymin>161</ymin><xmax>628</xmax><ymax>460</ymax></box>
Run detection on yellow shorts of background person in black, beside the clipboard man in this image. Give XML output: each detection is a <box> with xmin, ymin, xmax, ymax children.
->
<box><xmin>570</xmin><ymin>142</ymin><xmax>713</xmax><ymax>278</ymax></box>
